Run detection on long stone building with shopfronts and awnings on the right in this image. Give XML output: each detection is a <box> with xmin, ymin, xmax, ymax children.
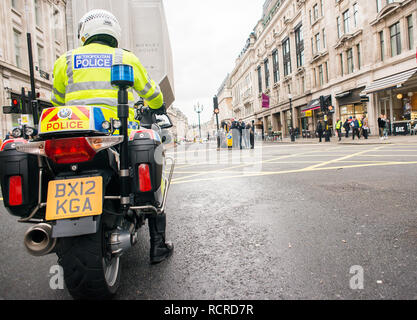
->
<box><xmin>224</xmin><ymin>0</ymin><xmax>417</xmax><ymax>135</ymax></box>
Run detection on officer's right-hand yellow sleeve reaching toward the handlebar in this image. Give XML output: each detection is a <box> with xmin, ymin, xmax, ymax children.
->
<box><xmin>128</xmin><ymin>53</ymin><xmax>164</xmax><ymax>109</ymax></box>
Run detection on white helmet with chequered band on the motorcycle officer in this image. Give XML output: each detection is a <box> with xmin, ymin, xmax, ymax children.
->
<box><xmin>78</xmin><ymin>9</ymin><xmax>122</xmax><ymax>46</ymax></box>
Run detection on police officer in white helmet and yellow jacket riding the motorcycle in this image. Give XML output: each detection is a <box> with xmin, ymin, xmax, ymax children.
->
<box><xmin>51</xmin><ymin>10</ymin><xmax>173</xmax><ymax>264</ymax></box>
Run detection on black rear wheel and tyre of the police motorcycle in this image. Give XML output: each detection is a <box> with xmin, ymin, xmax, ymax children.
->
<box><xmin>57</xmin><ymin>219</ymin><xmax>121</xmax><ymax>299</ymax></box>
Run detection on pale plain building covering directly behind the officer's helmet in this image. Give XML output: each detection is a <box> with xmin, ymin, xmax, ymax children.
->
<box><xmin>67</xmin><ymin>0</ymin><xmax>175</xmax><ymax>107</ymax></box>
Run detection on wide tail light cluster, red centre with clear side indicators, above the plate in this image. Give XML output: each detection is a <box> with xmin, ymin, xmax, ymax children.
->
<box><xmin>16</xmin><ymin>136</ymin><xmax>123</xmax><ymax>164</ymax></box>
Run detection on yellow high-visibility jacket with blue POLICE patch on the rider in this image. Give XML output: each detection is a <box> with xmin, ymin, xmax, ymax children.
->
<box><xmin>51</xmin><ymin>43</ymin><xmax>163</xmax><ymax>116</ymax></box>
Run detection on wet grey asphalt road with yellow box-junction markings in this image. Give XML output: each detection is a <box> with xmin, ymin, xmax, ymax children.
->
<box><xmin>0</xmin><ymin>139</ymin><xmax>417</xmax><ymax>300</ymax></box>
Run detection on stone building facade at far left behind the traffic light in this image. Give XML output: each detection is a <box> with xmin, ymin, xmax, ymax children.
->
<box><xmin>0</xmin><ymin>0</ymin><xmax>67</xmax><ymax>138</ymax></box>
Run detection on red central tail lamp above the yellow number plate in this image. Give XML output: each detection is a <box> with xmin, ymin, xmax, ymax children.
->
<box><xmin>45</xmin><ymin>138</ymin><xmax>96</xmax><ymax>164</ymax></box>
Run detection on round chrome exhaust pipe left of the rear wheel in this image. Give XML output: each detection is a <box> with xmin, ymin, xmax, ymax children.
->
<box><xmin>23</xmin><ymin>223</ymin><xmax>56</xmax><ymax>257</ymax></box>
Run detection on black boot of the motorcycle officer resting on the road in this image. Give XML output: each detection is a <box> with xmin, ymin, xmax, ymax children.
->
<box><xmin>148</xmin><ymin>213</ymin><xmax>174</xmax><ymax>264</ymax></box>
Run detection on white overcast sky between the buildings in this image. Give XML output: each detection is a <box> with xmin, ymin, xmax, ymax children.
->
<box><xmin>163</xmin><ymin>0</ymin><xmax>265</xmax><ymax>124</ymax></box>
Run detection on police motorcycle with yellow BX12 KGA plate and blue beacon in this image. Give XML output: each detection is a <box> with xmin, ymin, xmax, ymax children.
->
<box><xmin>0</xmin><ymin>65</ymin><xmax>175</xmax><ymax>299</ymax></box>
